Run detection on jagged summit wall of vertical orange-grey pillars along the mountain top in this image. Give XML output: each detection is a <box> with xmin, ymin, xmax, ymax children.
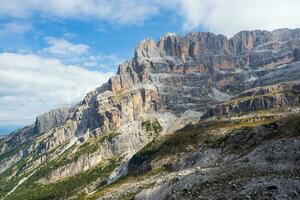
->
<box><xmin>110</xmin><ymin>29</ymin><xmax>299</xmax><ymax>85</ymax></box>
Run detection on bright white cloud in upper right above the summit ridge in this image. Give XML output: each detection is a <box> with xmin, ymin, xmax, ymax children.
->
<box><xmin>178</xmin><ymin>0</ymin><xmax>300</xmax><ymax>36</ymax></box>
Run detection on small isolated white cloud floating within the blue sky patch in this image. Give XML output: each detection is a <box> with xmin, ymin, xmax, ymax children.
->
<box><xmin>43</xmin><ymin>37</ymin><xmax>90</xmax><ymax>56</ymax></box>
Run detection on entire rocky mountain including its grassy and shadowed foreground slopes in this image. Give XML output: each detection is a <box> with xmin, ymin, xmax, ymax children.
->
<box><xmin>0</xmin><ymin>29</ymin><xmax>300</xmax><ymax>199</ymax></box>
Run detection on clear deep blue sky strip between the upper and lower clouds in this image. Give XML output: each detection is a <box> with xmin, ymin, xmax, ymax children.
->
<box><xmin>0</xmin><ymin>10</ymin><xmax>186</xmax><ymax>71</ymax></box>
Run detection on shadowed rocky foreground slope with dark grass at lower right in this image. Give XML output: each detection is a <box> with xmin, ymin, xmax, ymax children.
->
<box><xmin>98</xmin><ymin>113</ymin><xmax>300</xmax><ymax>200</ymax></box>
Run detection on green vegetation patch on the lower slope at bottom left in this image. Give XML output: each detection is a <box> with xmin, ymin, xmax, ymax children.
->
<box><xmin>7</xmin><ymin>159</ymin><xmax>119</xmax><ymax>200</ymax></box>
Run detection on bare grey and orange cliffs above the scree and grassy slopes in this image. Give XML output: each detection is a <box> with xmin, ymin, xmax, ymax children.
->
<box><xmin>1</xmin><ymin>29</ymin><xmax>300</xmax><ymax>168</ymax></box>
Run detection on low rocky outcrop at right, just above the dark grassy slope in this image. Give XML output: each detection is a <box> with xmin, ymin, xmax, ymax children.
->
<box><xmin>202</xmin><ymin>82</ymin><xmax>300</xmax><ymax>119</ymax></box>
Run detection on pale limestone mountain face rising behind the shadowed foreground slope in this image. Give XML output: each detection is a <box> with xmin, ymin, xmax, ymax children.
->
<box><xmin>0</xmin><ymin>29</ymin><xmax>300</xmax><ymax>200</ymax></box>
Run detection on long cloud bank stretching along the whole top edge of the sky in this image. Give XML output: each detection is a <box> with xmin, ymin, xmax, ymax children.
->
<box><xmin>0</xmin><ymin>0</ymin><xmax>300</xmax><ymax>36</ymax></box>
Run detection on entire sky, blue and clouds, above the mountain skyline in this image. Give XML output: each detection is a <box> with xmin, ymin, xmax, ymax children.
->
<box><xmin>0</xmin><ymin>0</ymin><xmax>300</xmax><ymax>134</ymax></box>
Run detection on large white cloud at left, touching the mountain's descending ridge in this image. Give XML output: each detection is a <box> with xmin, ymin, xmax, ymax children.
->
<box><xmin>0</xmin><ymin>53</ymin><xmax>113</xmax><ymax>125</ymax></box>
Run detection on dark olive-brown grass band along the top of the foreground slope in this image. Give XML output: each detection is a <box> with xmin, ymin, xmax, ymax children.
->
<box><xmin>129</xmin><ymin>113</ymin><xmax>300</xmax><ymax>176</ymax></box>
